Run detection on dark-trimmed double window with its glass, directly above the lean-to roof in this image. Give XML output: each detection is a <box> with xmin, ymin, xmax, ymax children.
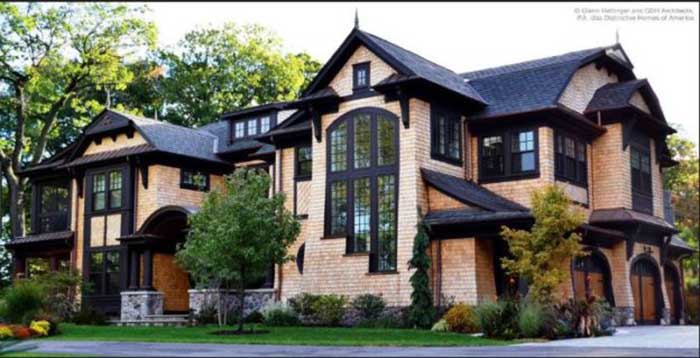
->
<box><xmin>479</xmin><ymin>128</ymin><xmax>539</xmax><ymax>181</ymax></box>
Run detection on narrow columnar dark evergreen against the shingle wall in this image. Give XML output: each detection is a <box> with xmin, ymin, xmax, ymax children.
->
<box><xmin>408</xmin><ymin>220</ymin><xmax>435</xmax><ymax>328</ymax></box>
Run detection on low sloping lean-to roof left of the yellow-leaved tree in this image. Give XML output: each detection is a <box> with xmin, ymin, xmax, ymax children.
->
<box><xmin>421</xmin><ymin>168</ymin><xmax>528</xmax><ymax>212</ymax></box>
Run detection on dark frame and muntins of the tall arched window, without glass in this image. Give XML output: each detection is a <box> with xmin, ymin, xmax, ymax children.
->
<box><xmin>324</xmin><ymin>107</ymin><xmax>400</xmax><ymax>272</ymax></box>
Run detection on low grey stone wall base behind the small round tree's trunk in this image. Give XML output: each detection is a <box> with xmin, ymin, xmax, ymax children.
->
<box><xmin>187</xmin><ymin>288</ymin><xmax>275</xmax><ymax>315</ymax></box>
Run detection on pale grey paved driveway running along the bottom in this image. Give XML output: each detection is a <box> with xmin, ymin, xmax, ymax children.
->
<box><xmin>10</xmin><ymin>326</ymin><xmax>700</xmax><ymax>357</ymax></box>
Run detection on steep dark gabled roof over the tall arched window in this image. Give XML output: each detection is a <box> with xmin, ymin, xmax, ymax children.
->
<box><xmin>304</xmin><ymin>28</ymin><xmax>485</xmax><ymax>104</ymax></box>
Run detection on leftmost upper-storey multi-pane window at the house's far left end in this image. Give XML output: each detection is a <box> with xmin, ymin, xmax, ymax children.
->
<box><xmin>36</xmin><ymin>182</ymin><xmax>69</xmax><ymax>233</ymax></box>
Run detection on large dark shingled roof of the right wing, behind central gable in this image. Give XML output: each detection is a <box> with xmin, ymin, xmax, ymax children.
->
<box><xmin>461</xmin><ymin>45</ymin><xmax>634</xmax><ymax>119</ymax></box>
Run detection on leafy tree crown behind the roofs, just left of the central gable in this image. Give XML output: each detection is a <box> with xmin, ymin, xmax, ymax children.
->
<box><xmin>159</xmin><ymin>23</ymin><xmax>320</xmax><ymax>126</ymax></box>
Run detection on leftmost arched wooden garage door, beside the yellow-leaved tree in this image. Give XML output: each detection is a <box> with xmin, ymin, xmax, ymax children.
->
<box><xmin>574</xmin><ymin>251</ymin><xmax>614</xmax><ymax>305</ymax></box>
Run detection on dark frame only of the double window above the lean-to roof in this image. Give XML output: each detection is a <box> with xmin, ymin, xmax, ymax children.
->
<box><xmin>477</xmin><ymin>126</ymin><xmax>540</xmax><ymax>183</ymax></box>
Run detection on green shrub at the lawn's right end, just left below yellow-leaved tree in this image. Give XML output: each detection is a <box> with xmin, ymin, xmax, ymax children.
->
<box><xmin>476</xmin><ymin>299</ymin><xmax>518</xmax><ymax>339</ymax></box>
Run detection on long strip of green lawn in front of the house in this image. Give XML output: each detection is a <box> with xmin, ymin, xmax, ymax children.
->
<box><xmin>43</xmin><ymin>324</ymin><xmax>513</xmax><ymax>346</ymax></box>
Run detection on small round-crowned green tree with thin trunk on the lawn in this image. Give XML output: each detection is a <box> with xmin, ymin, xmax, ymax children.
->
<box><xmin>176</xmin><ymin>169</ymin><xmax>300</xmax><ymax>331</ymax></box>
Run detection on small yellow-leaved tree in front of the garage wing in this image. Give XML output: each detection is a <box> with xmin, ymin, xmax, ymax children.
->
<box><xmin>501</xmin><ymin>185</ymin><xmax>584</xmax><ymax>303</ymax></box>
